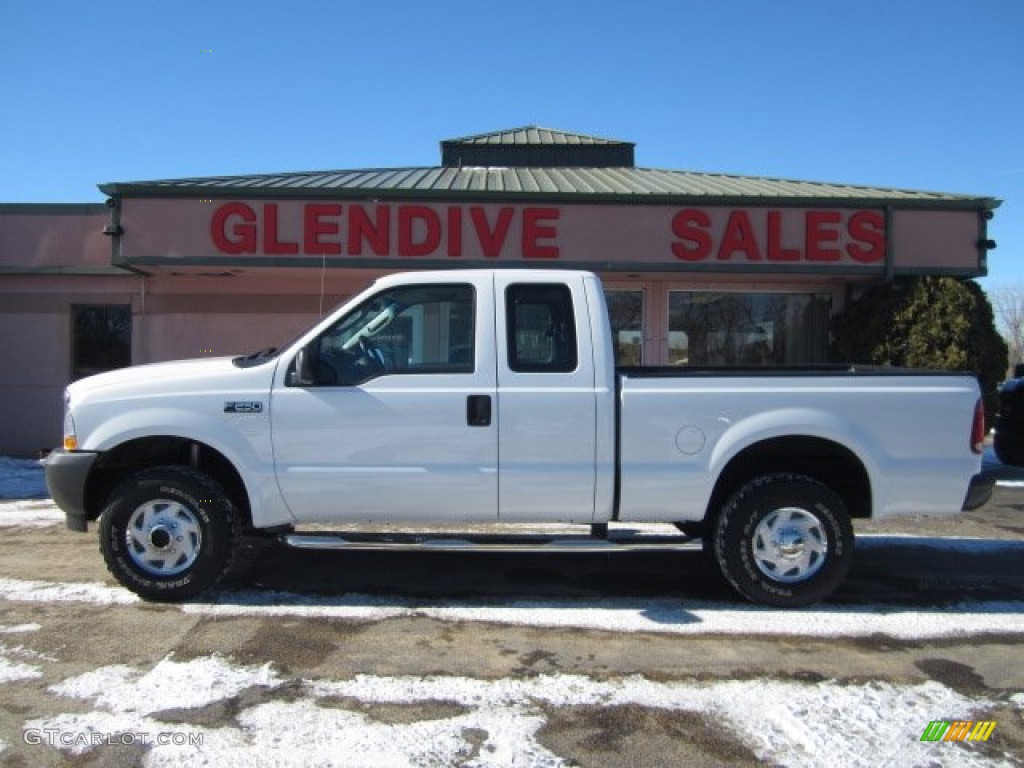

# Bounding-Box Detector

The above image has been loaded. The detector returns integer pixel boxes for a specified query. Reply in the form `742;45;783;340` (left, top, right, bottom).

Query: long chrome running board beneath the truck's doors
281;531;694;553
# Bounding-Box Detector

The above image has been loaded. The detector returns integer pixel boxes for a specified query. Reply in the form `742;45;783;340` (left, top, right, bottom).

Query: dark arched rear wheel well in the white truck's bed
705;436;871;522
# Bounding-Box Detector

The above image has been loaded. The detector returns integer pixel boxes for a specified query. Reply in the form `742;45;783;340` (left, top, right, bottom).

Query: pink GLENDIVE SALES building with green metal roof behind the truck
0;127;999;456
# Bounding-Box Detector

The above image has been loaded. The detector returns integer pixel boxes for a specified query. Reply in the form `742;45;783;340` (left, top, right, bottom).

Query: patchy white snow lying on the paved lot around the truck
0;459;1024;768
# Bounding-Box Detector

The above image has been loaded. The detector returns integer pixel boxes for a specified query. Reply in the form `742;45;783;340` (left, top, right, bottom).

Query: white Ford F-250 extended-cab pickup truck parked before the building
46;269;991;606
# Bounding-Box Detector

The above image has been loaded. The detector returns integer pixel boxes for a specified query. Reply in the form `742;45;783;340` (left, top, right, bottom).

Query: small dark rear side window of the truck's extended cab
505;284;578;373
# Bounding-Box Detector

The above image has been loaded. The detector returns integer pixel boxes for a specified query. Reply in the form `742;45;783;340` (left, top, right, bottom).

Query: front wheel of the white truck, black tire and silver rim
99;466;237;601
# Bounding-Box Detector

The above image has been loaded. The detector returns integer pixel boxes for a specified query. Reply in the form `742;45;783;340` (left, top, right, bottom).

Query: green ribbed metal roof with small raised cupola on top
99;126;999;210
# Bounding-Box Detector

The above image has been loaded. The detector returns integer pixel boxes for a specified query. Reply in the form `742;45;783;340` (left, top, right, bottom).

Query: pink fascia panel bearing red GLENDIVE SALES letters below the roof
121;199;979;271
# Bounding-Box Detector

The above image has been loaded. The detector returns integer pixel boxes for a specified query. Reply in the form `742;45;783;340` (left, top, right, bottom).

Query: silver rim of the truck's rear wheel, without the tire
753;507;828;584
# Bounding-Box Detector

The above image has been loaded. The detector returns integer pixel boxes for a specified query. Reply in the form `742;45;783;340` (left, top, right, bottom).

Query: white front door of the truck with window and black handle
271;276;498;521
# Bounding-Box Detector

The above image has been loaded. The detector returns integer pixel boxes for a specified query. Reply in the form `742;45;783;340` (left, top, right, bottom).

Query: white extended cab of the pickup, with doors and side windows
269;271;614;523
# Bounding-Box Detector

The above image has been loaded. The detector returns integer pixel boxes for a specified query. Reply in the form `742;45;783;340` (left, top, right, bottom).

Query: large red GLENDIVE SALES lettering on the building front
209;201;889;269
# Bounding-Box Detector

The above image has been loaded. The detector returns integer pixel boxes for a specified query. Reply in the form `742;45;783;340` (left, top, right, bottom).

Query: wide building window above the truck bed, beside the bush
669;291;831;367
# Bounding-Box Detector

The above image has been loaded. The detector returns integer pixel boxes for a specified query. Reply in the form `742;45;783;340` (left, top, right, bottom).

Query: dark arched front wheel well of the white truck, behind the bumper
85;436;252;525
